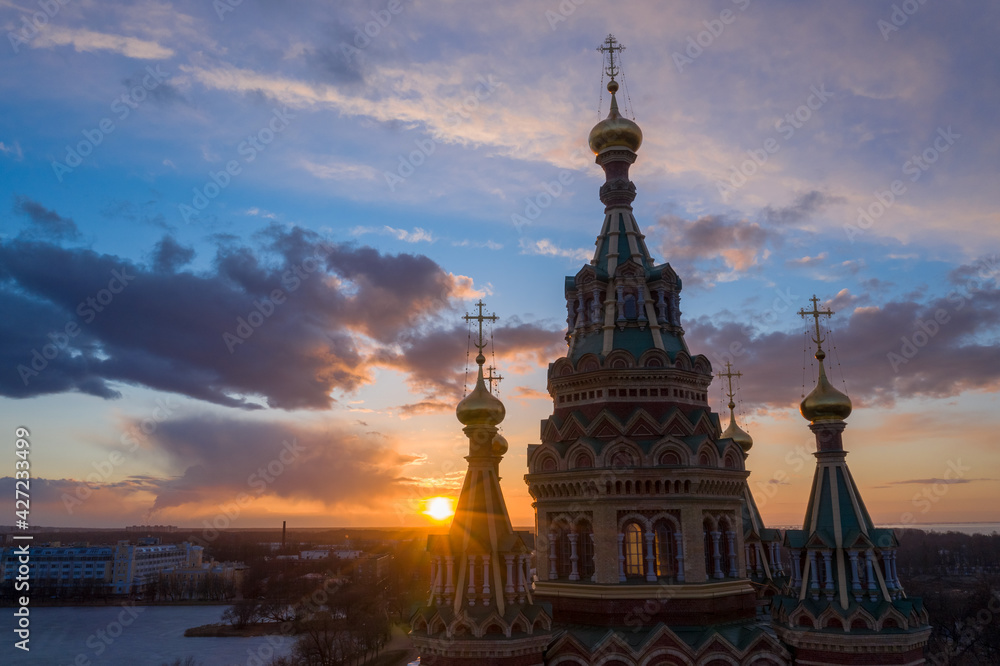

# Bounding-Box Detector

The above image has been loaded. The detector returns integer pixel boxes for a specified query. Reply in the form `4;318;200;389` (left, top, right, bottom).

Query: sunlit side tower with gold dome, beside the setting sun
410;301;552;666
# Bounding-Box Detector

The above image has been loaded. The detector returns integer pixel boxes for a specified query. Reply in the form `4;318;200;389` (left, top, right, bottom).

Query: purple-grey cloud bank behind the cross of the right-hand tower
685;288;1000;407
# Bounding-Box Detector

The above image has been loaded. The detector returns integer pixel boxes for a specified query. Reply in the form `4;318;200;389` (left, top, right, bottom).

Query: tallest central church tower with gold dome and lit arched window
525;35;787;666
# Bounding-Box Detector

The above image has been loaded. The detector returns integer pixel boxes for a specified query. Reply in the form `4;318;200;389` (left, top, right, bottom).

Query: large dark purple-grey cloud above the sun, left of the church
0;218;471;409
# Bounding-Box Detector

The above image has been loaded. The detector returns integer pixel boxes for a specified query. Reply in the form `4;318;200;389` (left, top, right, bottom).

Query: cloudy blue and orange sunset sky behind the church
0;0;1000;527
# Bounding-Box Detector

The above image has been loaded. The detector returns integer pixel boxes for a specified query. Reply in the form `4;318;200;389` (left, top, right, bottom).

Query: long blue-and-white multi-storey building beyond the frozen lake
0;541;203;594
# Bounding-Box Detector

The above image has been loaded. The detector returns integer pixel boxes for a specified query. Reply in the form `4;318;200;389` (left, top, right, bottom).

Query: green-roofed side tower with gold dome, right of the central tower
773;296;931;665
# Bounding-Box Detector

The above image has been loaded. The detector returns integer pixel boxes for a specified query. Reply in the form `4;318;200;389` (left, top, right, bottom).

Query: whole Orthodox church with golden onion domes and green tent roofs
410;35;930;666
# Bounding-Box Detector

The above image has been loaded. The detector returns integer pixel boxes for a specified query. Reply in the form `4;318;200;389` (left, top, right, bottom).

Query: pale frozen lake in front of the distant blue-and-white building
0;605;294;666
